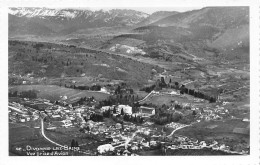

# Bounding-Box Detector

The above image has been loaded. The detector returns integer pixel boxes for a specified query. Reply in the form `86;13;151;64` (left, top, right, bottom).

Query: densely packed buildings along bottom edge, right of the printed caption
97;125;249;156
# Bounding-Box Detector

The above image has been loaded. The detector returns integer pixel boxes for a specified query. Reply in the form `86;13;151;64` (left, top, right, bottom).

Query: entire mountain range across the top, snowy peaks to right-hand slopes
9;7;249;61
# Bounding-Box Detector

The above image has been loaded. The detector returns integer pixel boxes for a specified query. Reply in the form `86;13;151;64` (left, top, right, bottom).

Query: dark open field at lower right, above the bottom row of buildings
175;119;249;151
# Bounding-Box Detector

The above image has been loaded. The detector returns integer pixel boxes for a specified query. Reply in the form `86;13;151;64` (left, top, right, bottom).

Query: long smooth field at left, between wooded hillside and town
9;85;109;101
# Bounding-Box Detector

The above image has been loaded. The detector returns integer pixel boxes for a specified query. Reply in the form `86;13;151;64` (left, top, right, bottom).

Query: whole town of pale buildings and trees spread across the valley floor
9;76;249;155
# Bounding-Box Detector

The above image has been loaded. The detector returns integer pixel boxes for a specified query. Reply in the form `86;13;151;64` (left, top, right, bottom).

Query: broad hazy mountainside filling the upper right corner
133;7;249;48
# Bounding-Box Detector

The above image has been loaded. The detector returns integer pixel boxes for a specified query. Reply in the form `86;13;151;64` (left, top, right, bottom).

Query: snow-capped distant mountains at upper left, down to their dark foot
9;8;149;35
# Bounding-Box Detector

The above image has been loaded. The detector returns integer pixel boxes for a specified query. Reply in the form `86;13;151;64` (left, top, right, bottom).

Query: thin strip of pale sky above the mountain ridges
63;7;202;14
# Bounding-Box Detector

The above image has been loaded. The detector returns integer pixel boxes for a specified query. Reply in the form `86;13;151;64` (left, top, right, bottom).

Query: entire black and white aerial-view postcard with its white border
1;1;259;164
